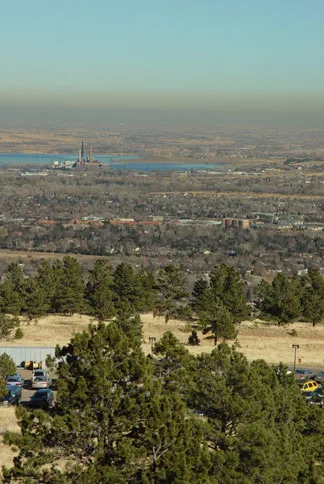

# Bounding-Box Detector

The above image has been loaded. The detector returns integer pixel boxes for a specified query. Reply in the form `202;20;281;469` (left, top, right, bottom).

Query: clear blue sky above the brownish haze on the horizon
0;0;324;105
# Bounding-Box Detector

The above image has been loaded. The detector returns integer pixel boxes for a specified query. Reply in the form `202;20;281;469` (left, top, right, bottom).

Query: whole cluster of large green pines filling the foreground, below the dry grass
3;317;324;484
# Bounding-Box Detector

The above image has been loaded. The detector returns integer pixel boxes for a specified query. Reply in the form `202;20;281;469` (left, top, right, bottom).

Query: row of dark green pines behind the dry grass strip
0;257;324;344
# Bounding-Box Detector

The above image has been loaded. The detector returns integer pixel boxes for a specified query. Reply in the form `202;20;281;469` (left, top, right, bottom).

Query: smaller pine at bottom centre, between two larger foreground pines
135;382;215;484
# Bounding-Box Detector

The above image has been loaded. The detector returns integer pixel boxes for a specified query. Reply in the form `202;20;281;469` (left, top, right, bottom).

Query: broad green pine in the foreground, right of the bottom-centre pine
191;345;316;484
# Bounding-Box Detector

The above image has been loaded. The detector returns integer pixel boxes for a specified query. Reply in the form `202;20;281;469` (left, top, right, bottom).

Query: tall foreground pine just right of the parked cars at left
2;323;151;484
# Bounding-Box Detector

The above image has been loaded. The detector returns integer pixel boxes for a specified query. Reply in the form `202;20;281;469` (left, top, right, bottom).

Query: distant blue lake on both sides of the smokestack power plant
0;153;222;172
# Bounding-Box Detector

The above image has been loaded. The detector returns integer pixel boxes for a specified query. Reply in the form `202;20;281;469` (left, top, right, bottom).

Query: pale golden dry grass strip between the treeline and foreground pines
0;314;324;368
